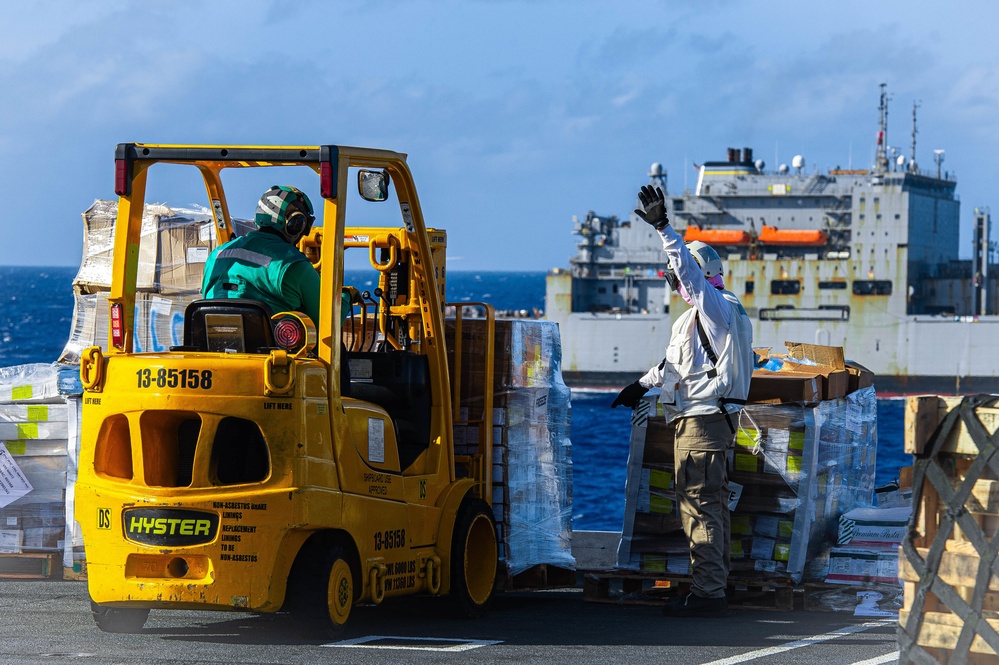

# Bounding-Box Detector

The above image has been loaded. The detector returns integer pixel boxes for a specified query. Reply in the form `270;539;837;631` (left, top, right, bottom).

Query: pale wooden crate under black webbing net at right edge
898;395;999;665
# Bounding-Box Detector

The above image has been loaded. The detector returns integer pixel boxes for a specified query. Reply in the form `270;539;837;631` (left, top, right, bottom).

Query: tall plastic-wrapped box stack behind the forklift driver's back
59;200;252;363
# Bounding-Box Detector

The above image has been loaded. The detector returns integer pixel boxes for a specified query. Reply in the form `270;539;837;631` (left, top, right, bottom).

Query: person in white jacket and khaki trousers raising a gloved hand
612;186;753;616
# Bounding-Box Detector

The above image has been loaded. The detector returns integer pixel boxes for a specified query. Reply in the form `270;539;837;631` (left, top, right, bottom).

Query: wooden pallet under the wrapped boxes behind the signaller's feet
583;571;806;612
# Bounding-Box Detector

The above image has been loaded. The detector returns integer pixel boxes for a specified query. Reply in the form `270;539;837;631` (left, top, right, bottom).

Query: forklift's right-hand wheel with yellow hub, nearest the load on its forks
449;497;499;619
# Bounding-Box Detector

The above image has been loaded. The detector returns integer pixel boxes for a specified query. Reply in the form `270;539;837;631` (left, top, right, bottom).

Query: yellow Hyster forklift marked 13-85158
76;143;498;632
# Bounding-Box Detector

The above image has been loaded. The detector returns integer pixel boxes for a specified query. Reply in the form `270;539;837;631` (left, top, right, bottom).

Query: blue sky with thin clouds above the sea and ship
0;0;999;270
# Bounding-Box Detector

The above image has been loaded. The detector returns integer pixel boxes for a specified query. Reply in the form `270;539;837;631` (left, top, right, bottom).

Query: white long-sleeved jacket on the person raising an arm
639;226;753;422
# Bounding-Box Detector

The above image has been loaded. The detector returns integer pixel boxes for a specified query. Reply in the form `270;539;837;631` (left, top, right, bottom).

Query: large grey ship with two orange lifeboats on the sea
545;84;999;394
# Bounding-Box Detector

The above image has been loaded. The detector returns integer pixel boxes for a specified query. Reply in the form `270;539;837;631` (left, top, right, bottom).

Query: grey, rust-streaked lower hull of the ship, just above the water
559;314;999;395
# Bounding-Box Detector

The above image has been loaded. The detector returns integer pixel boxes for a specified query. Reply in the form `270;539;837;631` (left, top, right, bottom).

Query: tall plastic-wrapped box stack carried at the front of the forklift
446;319;575;576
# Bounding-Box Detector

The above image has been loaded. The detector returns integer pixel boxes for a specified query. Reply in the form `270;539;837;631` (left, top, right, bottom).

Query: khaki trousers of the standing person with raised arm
673;413;737;598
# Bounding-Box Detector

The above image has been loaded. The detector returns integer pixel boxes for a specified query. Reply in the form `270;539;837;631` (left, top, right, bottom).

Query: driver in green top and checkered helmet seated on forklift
201;185;320;324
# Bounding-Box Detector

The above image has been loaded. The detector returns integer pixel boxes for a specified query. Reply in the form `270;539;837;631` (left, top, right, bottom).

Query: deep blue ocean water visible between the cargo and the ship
0;267;911;530
